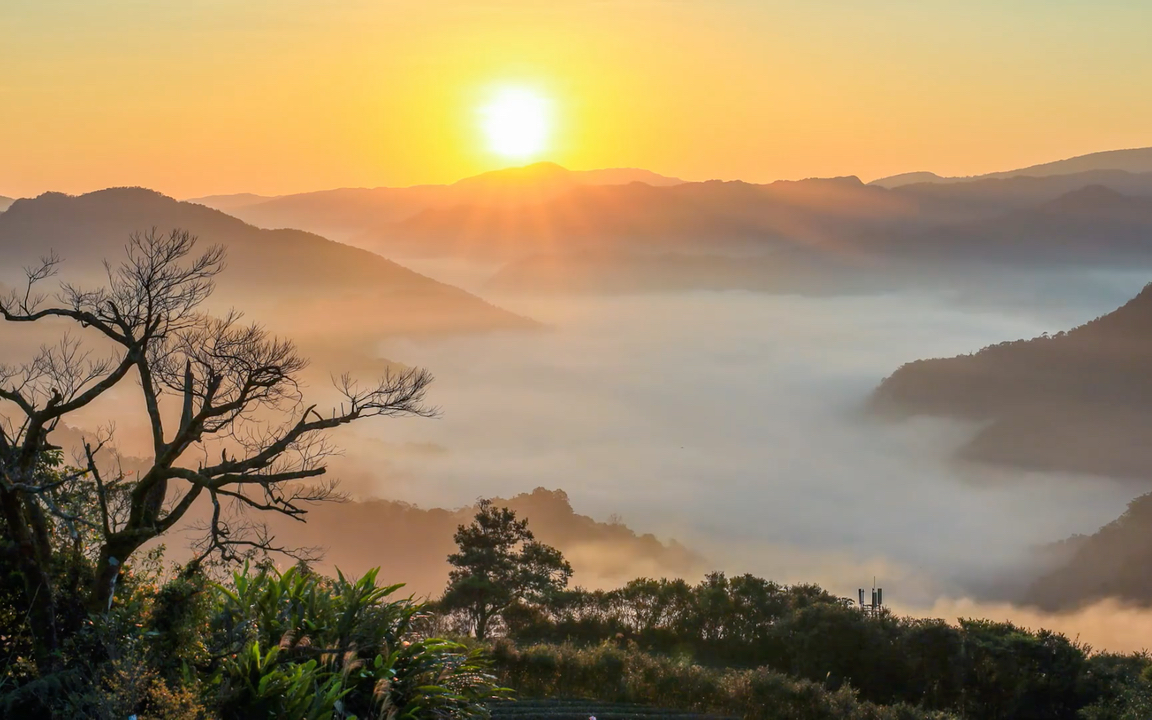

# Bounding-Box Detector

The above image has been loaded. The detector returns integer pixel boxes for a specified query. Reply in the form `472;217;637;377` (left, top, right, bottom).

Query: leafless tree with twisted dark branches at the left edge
0;229;433;669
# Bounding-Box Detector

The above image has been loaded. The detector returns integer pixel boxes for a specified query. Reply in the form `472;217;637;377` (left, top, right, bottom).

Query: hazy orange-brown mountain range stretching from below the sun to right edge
380;170;1152;265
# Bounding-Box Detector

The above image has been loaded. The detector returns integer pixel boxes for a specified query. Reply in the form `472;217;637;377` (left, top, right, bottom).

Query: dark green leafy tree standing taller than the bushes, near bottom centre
440;500;573;639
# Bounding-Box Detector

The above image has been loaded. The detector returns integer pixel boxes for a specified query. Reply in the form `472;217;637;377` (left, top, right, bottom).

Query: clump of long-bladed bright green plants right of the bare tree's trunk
211;566;506;720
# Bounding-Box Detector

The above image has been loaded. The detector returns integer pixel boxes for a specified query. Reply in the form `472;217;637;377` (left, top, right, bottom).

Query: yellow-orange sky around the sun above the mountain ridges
0;0;1152;197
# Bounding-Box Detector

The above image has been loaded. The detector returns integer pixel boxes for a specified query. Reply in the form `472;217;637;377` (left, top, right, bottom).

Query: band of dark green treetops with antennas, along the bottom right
505;573;1152;720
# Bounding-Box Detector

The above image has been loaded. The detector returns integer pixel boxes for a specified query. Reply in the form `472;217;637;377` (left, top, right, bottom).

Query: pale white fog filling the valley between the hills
344;265;1145;608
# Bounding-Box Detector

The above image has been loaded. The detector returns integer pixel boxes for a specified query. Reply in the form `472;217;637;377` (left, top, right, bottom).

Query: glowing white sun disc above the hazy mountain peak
480;88;552;160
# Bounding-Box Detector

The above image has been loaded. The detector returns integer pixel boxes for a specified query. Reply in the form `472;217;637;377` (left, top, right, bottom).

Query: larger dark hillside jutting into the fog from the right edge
870;286;1152;483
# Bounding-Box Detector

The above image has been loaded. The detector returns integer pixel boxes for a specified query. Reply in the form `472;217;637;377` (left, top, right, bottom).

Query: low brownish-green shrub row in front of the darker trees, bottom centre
492;641;953;720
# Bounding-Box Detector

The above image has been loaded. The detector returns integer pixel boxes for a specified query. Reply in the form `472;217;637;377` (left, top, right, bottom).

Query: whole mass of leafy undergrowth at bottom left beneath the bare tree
0;566;506;720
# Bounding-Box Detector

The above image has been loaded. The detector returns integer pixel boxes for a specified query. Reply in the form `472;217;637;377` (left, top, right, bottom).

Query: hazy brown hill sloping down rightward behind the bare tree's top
0;188;532;334
